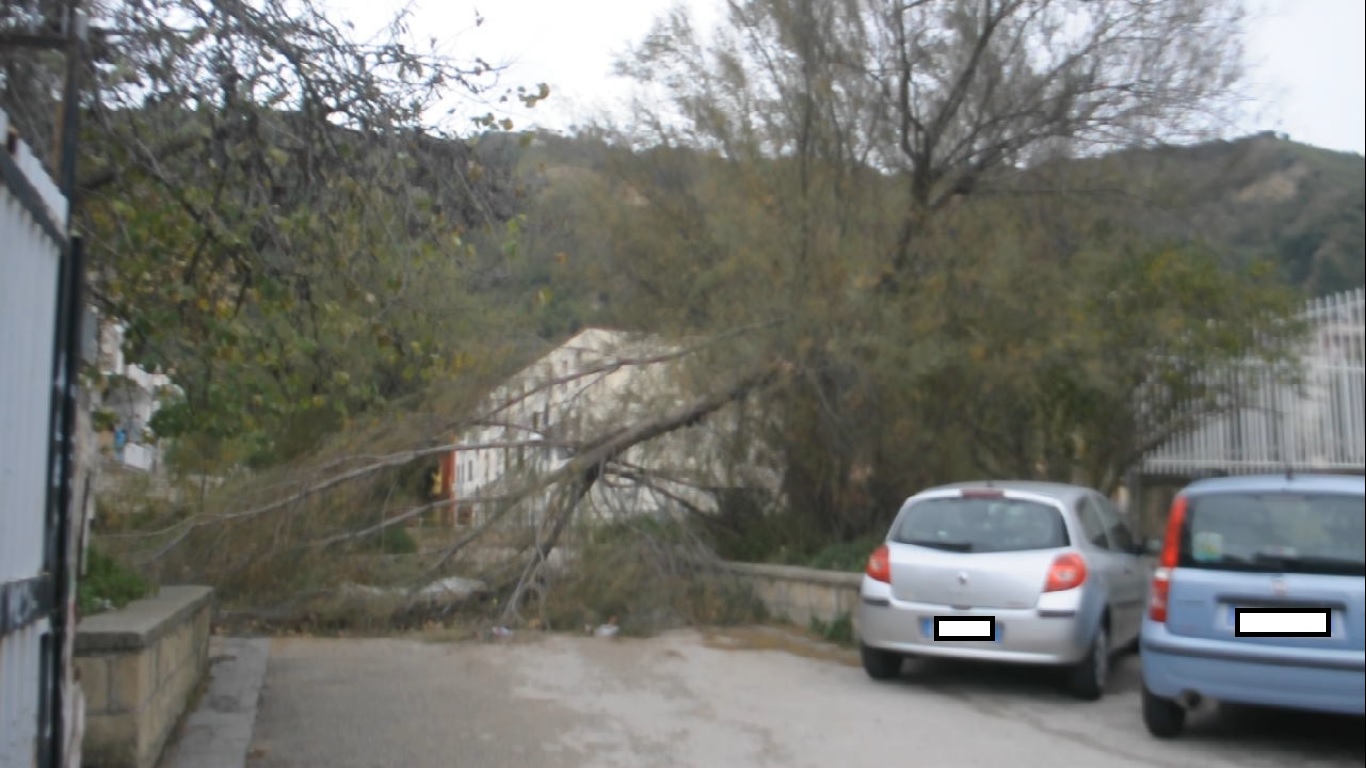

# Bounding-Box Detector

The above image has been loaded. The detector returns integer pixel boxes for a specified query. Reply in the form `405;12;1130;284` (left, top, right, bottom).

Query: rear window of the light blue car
1179;493;1366;575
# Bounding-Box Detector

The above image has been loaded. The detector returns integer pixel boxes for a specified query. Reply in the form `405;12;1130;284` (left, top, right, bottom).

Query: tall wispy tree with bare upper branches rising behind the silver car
584;0;1294;538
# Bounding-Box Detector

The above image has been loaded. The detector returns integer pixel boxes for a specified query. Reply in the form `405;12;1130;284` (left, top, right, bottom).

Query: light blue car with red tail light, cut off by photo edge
1139;474;1366;738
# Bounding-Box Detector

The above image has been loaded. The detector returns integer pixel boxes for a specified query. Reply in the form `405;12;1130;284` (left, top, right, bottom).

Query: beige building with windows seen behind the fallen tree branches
444;328;780;525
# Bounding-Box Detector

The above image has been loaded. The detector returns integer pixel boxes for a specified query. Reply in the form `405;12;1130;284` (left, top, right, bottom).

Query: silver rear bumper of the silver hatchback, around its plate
858;585;1094;666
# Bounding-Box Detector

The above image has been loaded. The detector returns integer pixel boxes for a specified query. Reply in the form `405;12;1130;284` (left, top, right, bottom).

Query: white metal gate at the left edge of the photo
0;112;67;767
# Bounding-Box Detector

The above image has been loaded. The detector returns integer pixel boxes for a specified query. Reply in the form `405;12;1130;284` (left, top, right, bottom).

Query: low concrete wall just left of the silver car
727;563;863;634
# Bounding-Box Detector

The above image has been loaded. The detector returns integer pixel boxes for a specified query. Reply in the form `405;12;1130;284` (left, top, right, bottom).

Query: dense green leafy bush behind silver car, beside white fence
932;192;1300;491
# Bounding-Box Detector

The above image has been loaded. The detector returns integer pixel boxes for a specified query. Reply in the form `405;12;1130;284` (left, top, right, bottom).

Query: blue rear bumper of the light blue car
1141;622;1366;715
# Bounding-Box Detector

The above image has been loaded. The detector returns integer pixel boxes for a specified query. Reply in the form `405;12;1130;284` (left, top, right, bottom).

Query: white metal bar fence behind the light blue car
1143;288;1366;476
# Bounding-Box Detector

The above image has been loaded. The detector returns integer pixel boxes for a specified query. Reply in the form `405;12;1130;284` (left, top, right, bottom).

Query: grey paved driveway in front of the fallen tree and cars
250;630;1366;768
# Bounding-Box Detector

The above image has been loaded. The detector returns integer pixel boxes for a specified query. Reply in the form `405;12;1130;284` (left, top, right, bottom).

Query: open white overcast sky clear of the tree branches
324;0;1366;153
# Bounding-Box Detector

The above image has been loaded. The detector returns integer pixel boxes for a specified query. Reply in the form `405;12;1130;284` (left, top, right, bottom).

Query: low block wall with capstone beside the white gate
75;586;213;768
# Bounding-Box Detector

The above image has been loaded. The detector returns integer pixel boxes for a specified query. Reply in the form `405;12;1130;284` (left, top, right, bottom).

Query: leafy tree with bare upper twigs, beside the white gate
3;0;546;461
